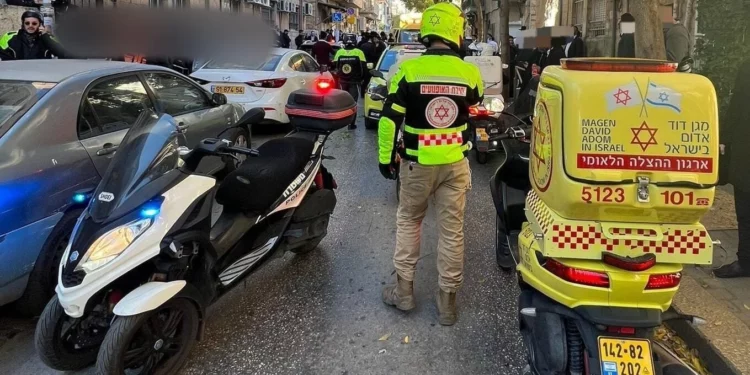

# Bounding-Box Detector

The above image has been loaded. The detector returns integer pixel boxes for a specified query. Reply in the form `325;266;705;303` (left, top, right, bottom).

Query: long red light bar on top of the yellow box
561;59;677;73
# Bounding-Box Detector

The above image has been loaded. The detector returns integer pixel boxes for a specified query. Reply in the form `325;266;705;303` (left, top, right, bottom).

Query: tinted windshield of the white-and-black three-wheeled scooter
89;111;180;222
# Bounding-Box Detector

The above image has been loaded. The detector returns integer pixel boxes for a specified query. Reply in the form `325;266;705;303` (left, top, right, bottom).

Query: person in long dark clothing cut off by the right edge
714;59;750;278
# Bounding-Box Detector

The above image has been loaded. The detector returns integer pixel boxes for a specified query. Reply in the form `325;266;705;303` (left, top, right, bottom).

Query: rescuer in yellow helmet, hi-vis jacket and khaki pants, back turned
378;2;484;325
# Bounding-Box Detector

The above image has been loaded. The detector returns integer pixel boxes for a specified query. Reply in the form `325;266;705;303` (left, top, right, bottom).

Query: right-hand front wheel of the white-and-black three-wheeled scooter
96;298;200;375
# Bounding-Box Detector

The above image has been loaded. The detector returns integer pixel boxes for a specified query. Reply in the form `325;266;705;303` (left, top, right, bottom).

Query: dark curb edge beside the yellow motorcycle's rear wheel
666;307;742;375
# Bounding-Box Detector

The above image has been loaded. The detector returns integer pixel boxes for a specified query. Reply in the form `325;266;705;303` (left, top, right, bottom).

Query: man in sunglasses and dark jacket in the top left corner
0;10;65;60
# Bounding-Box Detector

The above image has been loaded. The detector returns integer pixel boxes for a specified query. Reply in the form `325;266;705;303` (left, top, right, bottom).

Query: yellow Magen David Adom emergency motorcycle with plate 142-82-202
491;59;719;375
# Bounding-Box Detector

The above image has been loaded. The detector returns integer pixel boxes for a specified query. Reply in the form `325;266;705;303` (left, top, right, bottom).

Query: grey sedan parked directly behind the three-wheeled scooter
0;60;250;314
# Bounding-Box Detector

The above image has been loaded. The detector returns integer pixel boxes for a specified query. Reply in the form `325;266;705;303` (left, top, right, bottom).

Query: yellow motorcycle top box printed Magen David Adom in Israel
526;58;719;264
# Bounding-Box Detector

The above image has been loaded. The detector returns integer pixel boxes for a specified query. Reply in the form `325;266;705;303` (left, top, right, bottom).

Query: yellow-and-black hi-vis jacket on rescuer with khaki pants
378;49;484;165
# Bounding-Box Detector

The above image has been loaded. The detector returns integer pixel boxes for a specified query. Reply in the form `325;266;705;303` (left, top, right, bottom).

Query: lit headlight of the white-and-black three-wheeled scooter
76;218;151;273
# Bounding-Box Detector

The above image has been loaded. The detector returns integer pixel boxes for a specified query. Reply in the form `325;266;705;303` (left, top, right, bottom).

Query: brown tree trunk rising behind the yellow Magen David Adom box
630;0;667;60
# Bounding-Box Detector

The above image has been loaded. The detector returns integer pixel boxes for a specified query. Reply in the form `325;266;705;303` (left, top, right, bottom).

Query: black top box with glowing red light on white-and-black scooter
285;80;357;134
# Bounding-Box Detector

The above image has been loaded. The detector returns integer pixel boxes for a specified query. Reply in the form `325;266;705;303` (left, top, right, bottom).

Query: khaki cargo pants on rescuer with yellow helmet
393;158;471;293
